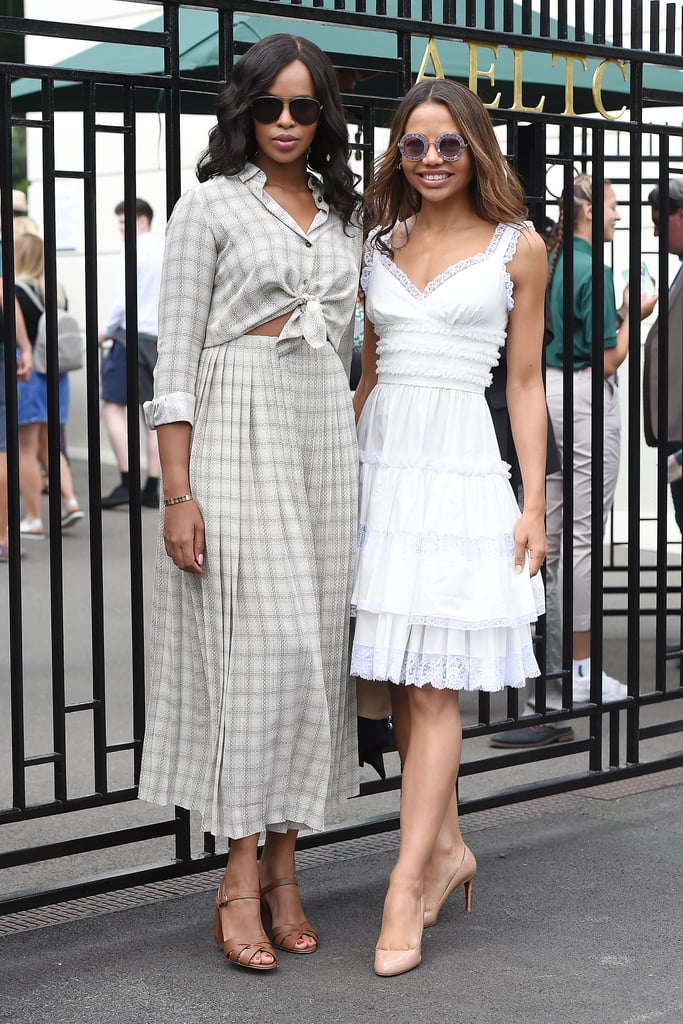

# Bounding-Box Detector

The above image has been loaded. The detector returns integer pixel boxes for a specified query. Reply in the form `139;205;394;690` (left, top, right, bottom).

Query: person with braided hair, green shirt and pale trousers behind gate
546;174;656;702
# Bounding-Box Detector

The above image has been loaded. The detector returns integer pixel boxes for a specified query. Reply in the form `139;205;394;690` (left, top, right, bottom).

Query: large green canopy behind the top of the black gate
12;0;683;114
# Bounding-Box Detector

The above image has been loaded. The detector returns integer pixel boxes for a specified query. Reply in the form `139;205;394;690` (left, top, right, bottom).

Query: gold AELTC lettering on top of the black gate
417;38;628;121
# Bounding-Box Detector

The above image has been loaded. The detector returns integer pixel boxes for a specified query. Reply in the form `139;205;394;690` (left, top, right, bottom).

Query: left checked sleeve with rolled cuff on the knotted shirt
144;189;217;429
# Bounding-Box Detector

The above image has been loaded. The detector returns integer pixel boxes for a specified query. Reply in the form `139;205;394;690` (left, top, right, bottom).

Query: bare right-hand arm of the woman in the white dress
506;231;548;575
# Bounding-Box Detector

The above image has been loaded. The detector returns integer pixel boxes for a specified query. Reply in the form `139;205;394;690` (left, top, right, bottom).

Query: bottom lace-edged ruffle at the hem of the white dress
351;642;541;692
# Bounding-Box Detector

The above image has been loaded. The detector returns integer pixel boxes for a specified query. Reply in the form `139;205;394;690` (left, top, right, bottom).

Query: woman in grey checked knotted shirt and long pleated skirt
139;35;361;970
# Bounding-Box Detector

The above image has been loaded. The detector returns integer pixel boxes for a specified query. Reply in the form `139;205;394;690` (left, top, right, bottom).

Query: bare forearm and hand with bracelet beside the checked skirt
157;422;204;575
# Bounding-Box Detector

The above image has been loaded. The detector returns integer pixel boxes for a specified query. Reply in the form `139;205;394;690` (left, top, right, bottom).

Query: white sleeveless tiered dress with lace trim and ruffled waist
351;224;544;691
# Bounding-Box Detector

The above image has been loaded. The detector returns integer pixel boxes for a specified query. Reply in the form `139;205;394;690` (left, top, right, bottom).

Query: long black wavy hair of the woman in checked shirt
197;33;361;227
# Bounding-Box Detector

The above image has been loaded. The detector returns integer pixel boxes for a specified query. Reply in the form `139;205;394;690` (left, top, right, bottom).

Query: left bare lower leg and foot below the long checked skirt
220;834;274;965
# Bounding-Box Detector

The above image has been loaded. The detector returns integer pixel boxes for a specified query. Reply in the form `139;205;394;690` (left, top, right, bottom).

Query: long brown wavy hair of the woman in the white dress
366;79;526;252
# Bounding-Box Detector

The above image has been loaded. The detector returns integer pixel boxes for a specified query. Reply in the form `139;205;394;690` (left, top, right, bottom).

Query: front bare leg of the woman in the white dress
378;686;462;949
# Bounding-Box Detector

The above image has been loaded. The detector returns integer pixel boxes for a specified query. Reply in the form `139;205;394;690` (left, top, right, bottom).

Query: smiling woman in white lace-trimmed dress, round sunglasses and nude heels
351;81;546;975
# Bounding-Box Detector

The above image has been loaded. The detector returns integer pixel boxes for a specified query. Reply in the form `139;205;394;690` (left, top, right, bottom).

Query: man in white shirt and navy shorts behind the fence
99;199;164;509
